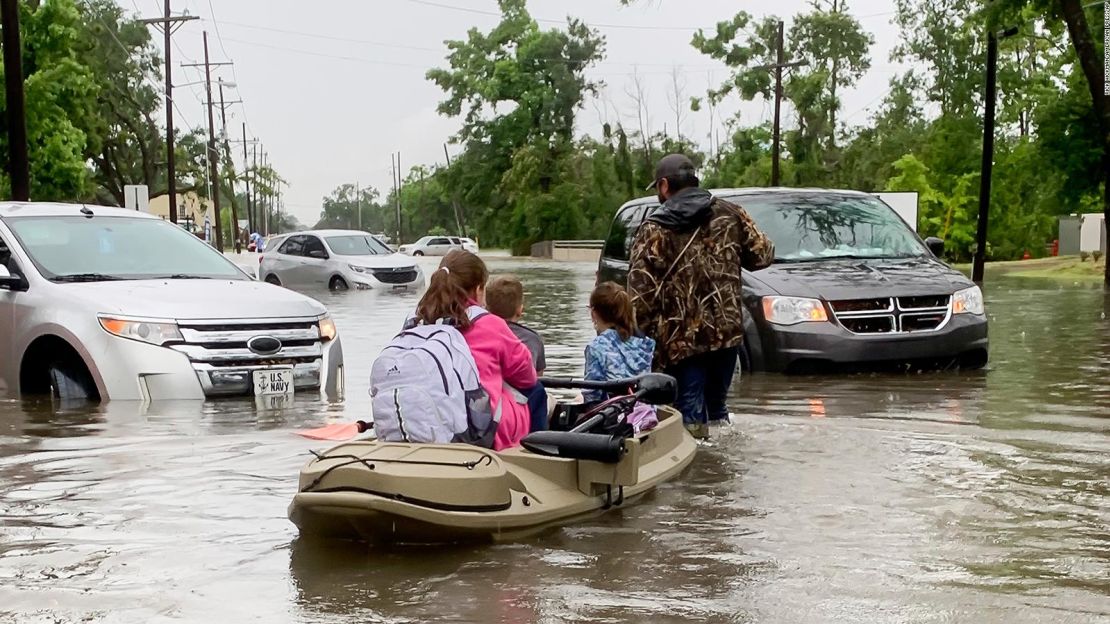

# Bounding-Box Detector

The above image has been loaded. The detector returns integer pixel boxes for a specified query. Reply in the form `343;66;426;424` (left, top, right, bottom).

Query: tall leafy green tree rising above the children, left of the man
427;0;604;245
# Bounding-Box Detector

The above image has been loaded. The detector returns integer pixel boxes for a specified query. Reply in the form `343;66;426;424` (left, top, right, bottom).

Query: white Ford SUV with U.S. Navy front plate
0;203;343;401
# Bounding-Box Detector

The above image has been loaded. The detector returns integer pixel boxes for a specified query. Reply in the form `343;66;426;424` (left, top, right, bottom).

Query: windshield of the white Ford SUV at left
7;217;249;281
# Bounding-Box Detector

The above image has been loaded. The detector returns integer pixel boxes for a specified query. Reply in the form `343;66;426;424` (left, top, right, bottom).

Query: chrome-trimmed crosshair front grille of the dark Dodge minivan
829;294;951;335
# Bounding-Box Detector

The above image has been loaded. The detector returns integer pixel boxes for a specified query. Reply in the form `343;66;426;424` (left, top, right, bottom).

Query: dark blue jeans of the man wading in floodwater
665;346;740;424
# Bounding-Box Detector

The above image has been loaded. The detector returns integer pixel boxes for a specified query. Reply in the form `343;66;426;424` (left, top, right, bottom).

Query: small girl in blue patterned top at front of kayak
583;282;655;424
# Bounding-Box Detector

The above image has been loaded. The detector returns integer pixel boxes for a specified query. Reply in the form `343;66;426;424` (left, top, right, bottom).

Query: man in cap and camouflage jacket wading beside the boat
628;154;775;439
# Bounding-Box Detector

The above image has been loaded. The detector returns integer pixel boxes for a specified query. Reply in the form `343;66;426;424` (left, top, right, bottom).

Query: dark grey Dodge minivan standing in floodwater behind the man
597;189;988;373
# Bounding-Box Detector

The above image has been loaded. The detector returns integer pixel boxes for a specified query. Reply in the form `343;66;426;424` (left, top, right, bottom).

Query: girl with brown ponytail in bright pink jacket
415;250;547;451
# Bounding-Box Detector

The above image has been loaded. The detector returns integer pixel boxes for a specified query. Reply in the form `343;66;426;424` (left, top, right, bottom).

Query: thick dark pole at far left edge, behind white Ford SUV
0;0;31;201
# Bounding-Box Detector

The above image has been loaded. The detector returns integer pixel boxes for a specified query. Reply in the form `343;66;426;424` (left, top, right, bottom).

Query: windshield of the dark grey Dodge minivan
729;192;928;262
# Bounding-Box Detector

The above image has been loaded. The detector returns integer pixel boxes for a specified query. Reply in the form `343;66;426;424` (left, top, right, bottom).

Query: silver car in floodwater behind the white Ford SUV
259;230;424;290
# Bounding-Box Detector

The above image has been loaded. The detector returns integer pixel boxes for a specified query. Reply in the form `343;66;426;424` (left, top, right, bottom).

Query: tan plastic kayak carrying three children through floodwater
289;395;697;544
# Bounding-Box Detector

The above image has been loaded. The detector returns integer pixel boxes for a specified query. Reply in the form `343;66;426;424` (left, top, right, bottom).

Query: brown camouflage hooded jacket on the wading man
628;189;775;370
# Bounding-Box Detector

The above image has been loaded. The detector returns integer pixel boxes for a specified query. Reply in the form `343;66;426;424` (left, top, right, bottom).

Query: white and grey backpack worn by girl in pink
370;305;501;449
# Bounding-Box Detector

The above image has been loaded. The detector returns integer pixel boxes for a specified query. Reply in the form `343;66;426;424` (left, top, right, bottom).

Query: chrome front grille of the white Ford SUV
170;319;324;395
